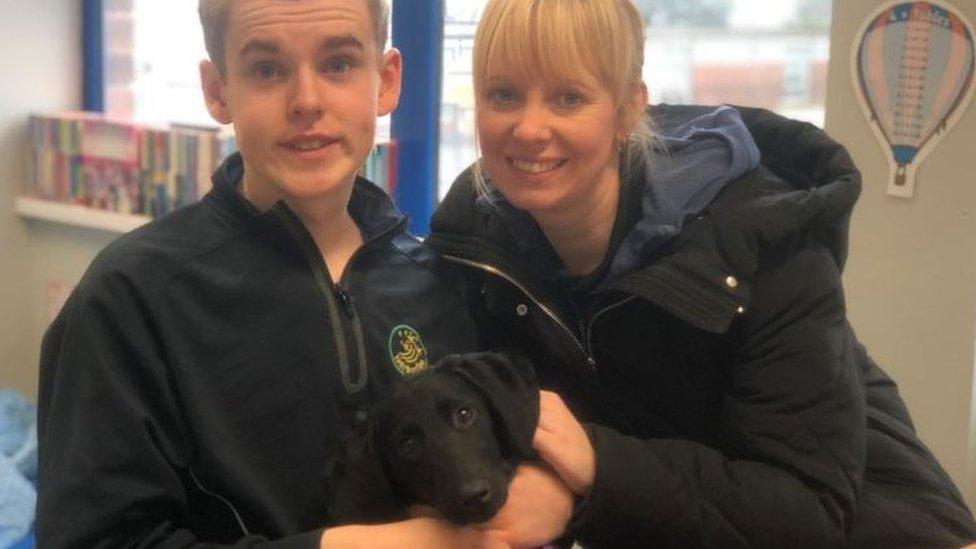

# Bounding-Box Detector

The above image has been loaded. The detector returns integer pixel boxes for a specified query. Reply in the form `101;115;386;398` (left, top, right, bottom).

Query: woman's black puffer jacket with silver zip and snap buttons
429;107;976;548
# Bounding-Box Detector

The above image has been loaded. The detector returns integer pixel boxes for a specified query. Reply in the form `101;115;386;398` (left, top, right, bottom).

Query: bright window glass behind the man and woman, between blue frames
93;0;831;222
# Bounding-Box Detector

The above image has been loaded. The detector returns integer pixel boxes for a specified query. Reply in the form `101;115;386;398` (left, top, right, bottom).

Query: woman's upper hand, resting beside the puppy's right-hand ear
532;391;596;496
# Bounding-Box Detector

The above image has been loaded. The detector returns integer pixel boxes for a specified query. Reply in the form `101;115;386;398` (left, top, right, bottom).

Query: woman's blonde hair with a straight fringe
473;0;654;194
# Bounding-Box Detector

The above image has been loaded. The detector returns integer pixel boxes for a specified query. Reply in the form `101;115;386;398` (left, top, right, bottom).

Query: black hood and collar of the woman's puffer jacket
429;106;861;333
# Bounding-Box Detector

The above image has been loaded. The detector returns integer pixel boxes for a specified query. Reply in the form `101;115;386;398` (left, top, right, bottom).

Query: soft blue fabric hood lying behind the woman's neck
607;106;760;279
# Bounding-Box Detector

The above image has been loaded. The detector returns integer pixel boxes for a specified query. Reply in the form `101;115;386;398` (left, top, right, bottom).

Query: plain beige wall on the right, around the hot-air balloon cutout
826;0;976;507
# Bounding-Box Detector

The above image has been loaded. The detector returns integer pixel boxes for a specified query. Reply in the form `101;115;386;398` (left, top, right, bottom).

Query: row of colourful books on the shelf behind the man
28;112;396;217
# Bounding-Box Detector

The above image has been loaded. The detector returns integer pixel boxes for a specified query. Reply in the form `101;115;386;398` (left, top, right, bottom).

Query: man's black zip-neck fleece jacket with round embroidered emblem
37;156;477;549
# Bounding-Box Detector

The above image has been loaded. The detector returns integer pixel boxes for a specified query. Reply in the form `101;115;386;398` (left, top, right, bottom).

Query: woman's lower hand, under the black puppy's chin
478;464;574;549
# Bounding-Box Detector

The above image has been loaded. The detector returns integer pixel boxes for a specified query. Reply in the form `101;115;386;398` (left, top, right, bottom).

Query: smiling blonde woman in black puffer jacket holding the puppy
430;0;976;548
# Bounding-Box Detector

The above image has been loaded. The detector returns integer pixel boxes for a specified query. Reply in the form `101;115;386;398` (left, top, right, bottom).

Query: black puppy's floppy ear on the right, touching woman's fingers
438;353;539;459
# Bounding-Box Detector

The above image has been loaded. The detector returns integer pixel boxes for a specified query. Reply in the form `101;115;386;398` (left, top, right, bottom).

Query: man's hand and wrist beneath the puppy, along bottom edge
319;517;510;549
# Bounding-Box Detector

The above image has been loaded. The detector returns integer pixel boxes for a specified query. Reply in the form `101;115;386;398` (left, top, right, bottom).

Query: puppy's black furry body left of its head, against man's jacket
326;420;403;525
